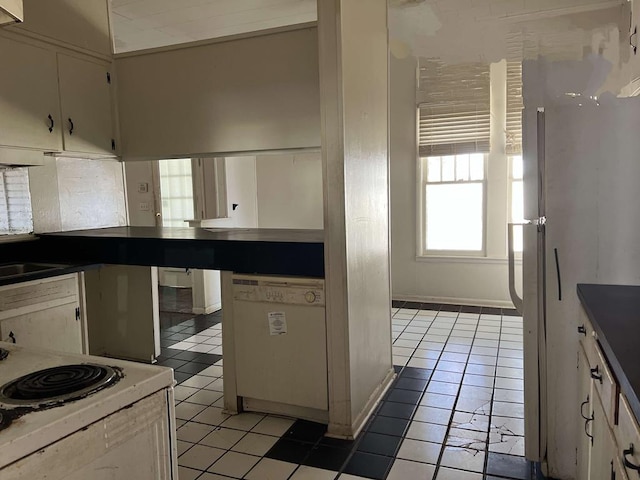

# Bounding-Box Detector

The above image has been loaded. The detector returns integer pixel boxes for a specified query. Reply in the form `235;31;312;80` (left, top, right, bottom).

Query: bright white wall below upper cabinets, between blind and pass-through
29;157;127;233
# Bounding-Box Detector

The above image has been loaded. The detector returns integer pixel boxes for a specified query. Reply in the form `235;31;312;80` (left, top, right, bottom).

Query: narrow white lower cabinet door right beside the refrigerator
577;344;592;479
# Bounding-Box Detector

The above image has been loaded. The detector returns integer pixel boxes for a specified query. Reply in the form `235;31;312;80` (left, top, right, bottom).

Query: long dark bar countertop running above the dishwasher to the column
28;227;324;278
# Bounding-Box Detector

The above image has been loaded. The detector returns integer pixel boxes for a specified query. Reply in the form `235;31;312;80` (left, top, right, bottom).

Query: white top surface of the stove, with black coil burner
0;342;174;468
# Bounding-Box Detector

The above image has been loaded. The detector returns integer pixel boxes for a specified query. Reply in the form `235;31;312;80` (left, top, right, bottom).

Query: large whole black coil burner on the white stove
0;363;121;407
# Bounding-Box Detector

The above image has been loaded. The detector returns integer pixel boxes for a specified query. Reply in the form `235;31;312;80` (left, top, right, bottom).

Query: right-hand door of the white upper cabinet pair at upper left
58;53;114;156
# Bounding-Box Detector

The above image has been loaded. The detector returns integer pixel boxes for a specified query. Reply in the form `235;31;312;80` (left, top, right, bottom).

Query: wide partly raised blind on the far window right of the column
418;60;491;157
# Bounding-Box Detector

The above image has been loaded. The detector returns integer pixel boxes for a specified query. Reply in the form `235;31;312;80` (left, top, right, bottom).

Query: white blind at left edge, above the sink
0;167;33;235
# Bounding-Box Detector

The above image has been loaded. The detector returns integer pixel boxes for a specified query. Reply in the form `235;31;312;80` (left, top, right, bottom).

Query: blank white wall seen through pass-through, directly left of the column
256;153;324;229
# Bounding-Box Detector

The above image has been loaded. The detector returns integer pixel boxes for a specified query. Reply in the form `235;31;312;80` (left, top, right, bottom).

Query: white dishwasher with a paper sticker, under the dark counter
232;274;328;420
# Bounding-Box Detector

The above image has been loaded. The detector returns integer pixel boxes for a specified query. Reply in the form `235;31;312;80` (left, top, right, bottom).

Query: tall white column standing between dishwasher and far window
318;0;394;437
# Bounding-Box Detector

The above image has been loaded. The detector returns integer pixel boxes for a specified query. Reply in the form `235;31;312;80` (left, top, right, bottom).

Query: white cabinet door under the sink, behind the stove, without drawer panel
0;302;83;353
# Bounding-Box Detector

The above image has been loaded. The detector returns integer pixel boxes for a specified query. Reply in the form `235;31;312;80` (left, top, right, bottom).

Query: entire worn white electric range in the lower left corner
0;342;178;480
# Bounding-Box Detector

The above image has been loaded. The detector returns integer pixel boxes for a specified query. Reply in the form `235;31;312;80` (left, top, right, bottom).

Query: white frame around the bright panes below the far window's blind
416;153;489;258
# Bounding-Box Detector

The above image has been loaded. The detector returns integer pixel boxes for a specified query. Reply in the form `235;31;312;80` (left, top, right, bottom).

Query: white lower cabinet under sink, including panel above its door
0;273;86;353
